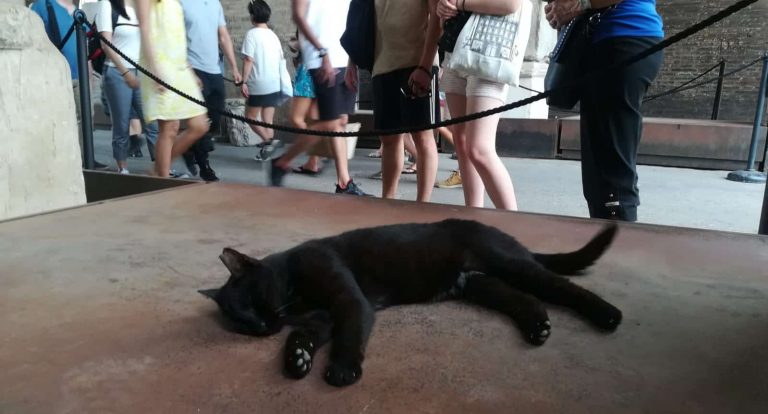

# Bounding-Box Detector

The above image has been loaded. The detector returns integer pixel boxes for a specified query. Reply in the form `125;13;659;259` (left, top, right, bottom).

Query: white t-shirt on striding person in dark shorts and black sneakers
299;0;350;69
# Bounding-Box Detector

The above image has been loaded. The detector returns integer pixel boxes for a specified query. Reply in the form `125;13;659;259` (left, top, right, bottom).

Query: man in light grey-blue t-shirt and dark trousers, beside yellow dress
180;0;242;181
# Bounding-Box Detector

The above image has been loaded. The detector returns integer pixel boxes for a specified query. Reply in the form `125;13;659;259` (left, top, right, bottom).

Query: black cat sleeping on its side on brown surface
200;219;621;386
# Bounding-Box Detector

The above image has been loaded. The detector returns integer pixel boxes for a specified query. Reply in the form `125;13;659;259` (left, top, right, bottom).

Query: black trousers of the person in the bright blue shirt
581;37;664;221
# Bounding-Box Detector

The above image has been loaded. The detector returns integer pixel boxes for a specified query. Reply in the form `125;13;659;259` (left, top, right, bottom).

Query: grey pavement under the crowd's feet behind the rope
94;130;765;233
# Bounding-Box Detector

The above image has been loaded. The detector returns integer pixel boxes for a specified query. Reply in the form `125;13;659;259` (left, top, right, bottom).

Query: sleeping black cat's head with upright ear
199;248;285;336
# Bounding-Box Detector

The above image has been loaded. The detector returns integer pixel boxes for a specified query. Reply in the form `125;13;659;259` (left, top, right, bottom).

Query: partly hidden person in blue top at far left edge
30;0;107;170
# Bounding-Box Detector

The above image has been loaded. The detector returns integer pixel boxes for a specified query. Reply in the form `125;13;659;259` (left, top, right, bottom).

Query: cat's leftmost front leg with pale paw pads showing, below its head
283;311;332;379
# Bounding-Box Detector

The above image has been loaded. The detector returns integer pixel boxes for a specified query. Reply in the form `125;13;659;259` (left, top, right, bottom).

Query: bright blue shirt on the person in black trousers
593;0;664;42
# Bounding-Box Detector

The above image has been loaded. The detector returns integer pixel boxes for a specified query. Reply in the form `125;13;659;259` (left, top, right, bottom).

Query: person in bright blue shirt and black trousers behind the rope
544;0;664;221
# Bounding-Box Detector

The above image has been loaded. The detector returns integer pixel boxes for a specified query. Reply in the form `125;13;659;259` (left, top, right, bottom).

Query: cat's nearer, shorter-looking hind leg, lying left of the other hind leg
463;274;551;346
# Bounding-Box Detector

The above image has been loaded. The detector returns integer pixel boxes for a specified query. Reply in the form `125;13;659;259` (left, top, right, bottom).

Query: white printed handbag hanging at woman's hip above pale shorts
446;0;533;86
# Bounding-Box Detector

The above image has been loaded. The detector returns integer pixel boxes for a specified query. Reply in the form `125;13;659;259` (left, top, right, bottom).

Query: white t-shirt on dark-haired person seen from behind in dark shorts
240;27;283;95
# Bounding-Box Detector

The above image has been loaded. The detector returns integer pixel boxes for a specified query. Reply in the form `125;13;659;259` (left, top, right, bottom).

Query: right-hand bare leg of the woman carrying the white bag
459;96;517;210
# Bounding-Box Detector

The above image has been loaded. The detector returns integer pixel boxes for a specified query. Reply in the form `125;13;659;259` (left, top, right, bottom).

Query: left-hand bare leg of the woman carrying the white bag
446;93;485;207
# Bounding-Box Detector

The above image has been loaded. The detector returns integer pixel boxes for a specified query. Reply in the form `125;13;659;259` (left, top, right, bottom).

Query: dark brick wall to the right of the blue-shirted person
643;0;768;121
